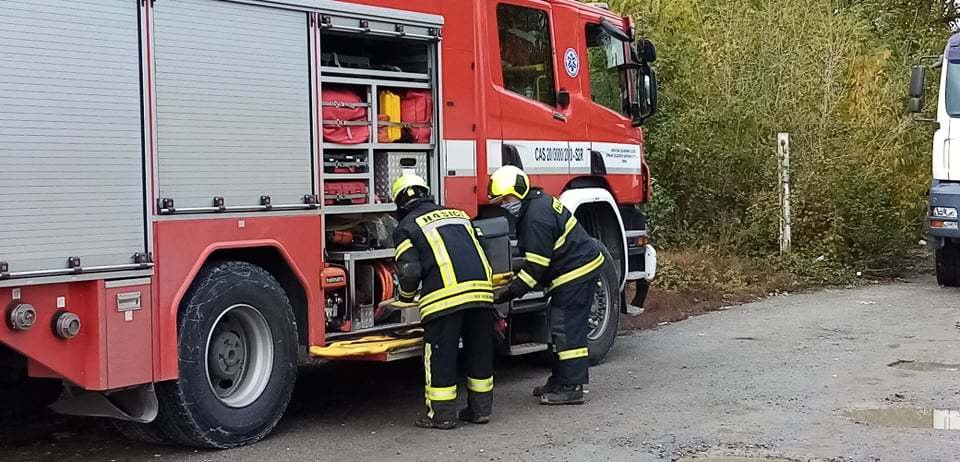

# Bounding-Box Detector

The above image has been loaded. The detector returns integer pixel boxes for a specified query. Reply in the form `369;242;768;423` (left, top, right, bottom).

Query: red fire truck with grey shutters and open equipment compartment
0;0;656;448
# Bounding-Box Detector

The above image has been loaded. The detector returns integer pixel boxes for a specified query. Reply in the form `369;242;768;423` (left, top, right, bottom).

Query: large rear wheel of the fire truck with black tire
155;262;298;449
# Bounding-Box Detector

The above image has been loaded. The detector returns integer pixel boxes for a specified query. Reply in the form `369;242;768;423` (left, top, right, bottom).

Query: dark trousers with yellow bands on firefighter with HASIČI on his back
423;306;496;420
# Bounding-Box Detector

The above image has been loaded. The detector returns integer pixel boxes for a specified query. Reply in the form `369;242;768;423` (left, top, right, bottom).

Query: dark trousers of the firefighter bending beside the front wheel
549;274;599;385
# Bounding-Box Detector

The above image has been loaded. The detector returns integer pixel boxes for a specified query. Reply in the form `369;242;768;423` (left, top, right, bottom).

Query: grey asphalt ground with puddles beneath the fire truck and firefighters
0;277;960;462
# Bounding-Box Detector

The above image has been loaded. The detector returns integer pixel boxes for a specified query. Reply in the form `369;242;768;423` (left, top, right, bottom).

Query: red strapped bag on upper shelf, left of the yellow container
320;87;370;144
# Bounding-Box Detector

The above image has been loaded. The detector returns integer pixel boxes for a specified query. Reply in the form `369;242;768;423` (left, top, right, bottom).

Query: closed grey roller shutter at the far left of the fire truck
0;0;146;273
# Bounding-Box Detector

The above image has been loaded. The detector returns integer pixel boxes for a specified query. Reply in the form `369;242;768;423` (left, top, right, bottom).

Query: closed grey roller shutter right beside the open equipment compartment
154;0;313;208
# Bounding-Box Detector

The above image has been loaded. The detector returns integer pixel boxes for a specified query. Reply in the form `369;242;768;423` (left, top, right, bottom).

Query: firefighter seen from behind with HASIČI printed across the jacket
391;173;496;429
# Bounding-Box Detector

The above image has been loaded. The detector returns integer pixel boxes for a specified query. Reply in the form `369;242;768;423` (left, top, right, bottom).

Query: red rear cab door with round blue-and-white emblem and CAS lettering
487;0;587;188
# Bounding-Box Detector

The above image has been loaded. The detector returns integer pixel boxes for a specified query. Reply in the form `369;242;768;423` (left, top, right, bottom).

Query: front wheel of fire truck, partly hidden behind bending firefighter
587;244;623;366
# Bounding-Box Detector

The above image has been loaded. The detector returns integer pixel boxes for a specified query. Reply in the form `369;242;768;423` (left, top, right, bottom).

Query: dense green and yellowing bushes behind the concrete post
609;0;957;272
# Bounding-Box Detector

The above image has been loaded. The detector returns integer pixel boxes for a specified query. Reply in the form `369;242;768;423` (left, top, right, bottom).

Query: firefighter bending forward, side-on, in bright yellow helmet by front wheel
488;166;604;404
